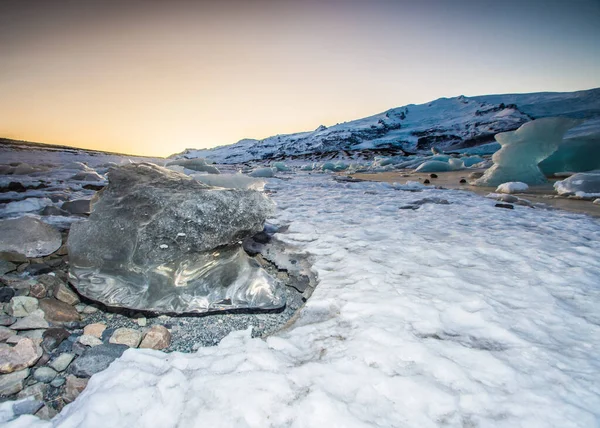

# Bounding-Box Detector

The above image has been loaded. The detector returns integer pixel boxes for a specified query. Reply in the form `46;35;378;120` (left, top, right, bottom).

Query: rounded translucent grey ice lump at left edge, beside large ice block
0;217;62;257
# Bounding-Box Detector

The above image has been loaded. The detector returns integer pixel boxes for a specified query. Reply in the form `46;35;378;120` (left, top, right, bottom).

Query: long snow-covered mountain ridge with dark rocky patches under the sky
177;88;600;164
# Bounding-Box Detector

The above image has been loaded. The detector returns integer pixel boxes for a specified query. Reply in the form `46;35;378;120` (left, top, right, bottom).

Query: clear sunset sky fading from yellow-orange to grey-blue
0;0;600;156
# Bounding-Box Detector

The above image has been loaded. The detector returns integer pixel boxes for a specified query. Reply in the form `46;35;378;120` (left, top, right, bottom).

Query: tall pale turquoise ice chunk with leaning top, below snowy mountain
473;117;581;186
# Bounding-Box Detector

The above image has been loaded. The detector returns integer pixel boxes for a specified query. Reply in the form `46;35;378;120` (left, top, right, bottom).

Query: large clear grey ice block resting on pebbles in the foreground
68;164;284;313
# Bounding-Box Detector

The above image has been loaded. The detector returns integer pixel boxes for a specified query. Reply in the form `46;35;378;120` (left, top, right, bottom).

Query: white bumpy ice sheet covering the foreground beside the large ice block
14;175;600;427
